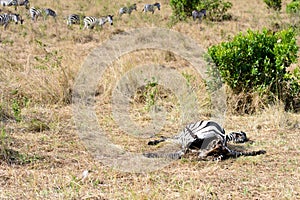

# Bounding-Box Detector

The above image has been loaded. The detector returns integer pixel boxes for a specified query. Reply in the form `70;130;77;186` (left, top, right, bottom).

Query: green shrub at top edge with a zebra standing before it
170;0;232;21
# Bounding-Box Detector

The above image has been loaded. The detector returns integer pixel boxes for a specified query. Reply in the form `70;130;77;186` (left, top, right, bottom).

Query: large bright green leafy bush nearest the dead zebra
208;29;300;111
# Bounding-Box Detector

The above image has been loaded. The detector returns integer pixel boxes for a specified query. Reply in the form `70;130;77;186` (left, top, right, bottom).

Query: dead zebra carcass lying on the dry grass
144;120;266;160
